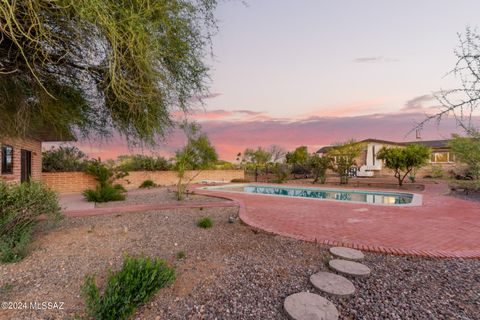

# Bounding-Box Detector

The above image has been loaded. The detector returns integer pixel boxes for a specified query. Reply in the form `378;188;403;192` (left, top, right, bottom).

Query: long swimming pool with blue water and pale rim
204;184;421;205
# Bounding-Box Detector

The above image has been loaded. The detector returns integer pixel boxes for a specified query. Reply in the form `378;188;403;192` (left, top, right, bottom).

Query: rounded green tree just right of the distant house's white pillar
377;144;430;186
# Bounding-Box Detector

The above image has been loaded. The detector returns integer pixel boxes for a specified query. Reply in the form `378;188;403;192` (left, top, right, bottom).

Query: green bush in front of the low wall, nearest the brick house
83;160;128;202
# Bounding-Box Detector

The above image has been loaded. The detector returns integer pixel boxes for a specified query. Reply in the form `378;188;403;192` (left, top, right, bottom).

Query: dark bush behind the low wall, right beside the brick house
42;146;87;172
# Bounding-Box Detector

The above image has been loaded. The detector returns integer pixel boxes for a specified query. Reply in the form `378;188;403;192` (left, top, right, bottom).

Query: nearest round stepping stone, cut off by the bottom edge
283;292;338;320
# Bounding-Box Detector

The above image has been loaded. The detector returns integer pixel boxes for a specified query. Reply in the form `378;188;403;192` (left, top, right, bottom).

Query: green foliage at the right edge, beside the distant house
448;131;480;179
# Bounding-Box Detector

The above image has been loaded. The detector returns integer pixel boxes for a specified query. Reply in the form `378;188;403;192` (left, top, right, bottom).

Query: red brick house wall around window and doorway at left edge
0;138;42;182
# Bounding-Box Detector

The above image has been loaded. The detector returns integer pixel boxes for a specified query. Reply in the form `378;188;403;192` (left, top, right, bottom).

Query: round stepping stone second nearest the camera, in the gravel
310;272;355;297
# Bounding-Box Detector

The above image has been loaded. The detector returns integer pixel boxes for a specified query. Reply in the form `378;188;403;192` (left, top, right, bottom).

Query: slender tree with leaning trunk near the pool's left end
174;121;218;201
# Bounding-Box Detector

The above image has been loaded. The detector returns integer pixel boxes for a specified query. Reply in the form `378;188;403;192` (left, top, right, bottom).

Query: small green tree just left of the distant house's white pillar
327;140;364;184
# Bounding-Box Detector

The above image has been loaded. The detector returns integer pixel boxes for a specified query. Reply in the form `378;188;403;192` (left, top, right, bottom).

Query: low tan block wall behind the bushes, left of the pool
42;170;245;193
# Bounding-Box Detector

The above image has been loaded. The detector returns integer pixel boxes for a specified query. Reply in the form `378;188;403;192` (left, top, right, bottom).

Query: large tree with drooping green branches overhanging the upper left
0;0;216;144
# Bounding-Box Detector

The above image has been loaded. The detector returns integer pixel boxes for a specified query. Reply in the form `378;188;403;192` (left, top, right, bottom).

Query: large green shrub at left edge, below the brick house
0;181;61;263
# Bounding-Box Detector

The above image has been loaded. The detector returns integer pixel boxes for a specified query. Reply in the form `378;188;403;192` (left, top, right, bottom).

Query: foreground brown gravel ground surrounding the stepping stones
0;204;480;320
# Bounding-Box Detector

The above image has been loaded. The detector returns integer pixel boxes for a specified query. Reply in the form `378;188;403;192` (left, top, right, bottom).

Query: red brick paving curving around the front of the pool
196;184;480;258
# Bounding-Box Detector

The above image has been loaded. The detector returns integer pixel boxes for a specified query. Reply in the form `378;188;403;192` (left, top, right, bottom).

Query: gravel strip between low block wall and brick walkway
95;187;226;208
